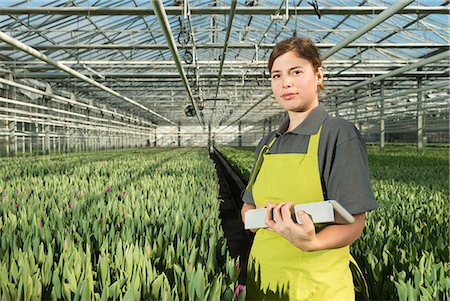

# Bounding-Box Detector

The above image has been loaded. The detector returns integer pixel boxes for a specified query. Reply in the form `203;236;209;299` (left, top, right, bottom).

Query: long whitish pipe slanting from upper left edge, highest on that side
0;31;176;125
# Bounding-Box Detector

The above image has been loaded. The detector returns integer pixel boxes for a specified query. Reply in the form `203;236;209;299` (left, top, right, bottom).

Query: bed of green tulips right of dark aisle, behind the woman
216;147;450;300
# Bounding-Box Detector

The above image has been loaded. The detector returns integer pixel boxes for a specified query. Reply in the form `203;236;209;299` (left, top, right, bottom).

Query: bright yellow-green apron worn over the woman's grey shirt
246;129;364;301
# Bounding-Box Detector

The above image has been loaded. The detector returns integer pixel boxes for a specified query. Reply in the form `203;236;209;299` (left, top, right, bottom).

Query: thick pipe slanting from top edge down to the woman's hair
322;0;414;60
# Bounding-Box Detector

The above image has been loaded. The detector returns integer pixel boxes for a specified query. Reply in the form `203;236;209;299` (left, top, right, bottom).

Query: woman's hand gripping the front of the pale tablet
266;202;318;251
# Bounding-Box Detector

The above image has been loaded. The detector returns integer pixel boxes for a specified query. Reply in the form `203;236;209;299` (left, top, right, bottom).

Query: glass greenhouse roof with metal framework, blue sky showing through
0;0;450;127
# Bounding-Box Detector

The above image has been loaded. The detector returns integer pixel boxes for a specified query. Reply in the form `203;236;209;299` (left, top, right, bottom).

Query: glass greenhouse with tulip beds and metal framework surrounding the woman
0;0;450;300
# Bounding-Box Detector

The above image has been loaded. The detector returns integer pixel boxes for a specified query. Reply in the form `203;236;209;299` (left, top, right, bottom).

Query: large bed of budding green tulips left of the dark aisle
0;149;243;300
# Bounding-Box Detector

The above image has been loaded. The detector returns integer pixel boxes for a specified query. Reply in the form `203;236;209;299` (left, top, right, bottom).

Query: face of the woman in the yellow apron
271;51;323;112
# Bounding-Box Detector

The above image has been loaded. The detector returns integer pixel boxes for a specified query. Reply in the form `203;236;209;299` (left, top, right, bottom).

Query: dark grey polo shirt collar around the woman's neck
277;104;329;135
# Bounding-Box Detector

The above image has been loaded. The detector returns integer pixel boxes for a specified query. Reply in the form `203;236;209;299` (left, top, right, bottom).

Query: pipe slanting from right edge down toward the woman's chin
322;51;450;100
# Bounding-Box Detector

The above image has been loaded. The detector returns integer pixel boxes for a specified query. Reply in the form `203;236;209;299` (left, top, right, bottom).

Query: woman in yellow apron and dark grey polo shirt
242;37;377;300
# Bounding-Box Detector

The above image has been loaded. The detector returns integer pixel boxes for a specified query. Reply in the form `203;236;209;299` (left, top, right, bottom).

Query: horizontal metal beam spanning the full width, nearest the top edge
0;6;450;16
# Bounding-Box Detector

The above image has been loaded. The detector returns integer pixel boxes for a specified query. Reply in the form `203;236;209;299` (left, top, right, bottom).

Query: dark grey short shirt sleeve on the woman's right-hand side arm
323;122;378;214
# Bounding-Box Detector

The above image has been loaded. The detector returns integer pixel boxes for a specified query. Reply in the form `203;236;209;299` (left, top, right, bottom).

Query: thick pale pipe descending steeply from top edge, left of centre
150;0;205;128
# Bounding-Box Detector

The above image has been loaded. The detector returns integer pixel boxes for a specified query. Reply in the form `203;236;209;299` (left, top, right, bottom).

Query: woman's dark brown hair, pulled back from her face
268;37;324;91
